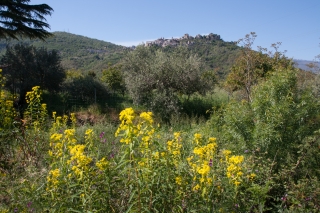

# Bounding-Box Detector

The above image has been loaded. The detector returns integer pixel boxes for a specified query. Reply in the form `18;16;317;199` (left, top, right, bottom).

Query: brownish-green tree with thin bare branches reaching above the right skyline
226;32;294;101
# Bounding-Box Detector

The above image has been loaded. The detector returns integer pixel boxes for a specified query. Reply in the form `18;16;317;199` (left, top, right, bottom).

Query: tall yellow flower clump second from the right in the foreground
187;133;217;191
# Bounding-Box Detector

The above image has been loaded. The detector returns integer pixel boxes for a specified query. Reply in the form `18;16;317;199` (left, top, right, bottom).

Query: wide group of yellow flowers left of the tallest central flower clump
47;116;110;205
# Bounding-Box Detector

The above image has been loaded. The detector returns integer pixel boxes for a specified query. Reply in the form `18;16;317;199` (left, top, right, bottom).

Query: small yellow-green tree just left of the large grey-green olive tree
101;63;126;95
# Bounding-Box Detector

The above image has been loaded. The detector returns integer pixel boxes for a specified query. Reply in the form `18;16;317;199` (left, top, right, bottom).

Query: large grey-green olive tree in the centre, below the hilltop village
123;46;212;121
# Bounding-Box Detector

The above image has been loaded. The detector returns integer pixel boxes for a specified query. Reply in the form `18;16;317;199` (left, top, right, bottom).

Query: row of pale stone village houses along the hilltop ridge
145;33;221;47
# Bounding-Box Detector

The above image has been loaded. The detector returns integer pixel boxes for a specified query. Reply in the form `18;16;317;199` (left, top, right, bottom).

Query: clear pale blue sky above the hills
29;0;320;60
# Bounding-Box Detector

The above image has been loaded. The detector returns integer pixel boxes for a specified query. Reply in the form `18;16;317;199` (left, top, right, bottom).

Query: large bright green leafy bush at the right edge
215;70;320;158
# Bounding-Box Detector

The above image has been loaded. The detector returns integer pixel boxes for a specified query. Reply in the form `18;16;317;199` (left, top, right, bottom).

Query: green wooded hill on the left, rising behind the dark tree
0;32;130;71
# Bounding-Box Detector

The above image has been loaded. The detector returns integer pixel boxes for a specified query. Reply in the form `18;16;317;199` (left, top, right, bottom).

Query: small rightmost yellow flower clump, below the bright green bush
223;150;244;187
